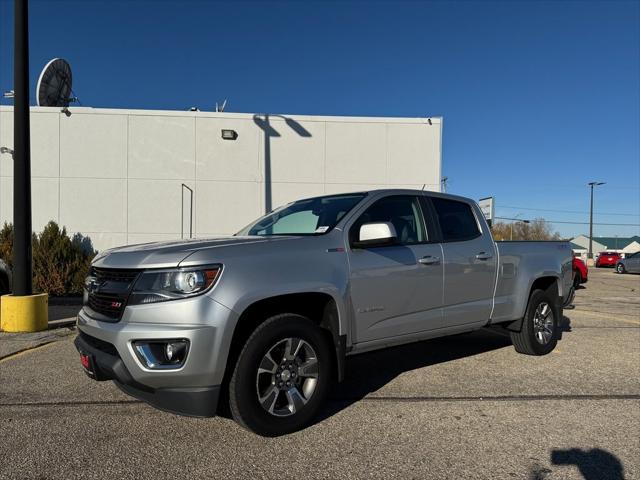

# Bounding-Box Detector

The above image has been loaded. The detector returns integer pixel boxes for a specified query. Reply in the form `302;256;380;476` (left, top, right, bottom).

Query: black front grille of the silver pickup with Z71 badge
85;267;140;321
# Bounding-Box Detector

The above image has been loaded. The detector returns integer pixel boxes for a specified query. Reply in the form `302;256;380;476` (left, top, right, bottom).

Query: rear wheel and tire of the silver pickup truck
511;290;559;355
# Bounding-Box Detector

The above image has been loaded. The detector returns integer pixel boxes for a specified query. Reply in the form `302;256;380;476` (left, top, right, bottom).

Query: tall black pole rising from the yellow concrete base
13;0;33;297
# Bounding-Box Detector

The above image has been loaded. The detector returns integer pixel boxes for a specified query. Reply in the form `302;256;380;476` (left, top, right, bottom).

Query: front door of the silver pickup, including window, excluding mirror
349;195;443;343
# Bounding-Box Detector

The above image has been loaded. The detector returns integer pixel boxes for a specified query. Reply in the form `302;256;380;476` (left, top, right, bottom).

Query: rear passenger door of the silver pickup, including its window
427;196;497;326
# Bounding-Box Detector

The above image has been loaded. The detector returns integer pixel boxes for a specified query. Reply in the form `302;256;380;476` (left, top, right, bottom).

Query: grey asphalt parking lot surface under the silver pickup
0;268;640;479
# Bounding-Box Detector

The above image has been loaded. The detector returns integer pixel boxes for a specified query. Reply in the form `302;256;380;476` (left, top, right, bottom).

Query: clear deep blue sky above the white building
0;0;640;240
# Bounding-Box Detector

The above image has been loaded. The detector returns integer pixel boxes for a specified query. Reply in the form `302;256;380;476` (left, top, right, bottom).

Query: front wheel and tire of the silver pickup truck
229;314;335;437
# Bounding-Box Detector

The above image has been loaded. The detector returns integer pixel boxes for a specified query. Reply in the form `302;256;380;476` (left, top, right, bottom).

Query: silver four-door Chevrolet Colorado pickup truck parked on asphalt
75;190;572;436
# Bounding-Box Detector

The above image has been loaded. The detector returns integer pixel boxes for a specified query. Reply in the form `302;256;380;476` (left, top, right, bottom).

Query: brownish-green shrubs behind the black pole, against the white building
0;221;96;295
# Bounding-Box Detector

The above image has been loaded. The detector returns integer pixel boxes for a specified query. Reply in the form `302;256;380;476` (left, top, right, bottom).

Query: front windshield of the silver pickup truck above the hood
236;193;366;236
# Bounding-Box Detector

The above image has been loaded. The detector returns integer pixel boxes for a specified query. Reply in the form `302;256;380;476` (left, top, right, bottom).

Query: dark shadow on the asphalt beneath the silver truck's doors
316;330;512;422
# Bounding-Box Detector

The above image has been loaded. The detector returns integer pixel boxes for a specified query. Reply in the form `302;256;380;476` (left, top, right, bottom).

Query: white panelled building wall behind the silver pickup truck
0;107;442;250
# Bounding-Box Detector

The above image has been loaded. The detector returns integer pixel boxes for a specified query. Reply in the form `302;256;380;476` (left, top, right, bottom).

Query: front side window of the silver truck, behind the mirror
349;195;427;245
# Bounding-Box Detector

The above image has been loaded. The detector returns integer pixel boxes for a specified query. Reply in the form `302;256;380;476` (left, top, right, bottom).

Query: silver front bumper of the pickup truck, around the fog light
75;296;237;417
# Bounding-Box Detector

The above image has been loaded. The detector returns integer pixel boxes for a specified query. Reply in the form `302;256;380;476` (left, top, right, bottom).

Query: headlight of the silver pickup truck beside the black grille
128;265;222;305
